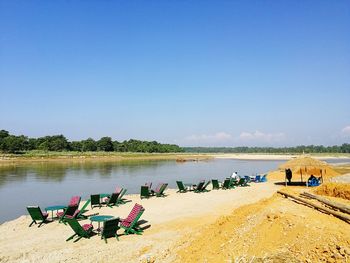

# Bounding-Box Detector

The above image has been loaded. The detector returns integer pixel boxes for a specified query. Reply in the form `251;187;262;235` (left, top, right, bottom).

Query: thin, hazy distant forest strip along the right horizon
183;143;350;154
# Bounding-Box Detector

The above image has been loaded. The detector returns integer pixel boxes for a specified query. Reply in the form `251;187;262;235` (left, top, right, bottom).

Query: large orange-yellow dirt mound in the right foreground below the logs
176;194;350;262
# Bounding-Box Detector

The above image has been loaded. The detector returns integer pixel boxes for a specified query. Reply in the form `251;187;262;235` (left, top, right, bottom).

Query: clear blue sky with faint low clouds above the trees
0;0;350;146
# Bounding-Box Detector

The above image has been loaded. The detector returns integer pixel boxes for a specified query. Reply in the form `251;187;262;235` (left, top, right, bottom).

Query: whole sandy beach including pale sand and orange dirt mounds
0;158;350;262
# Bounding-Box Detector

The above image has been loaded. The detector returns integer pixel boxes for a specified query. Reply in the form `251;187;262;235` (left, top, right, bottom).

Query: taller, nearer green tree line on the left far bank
0;130;183;153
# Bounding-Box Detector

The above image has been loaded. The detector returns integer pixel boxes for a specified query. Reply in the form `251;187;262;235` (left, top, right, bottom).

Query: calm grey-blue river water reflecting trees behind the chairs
0;159;348;223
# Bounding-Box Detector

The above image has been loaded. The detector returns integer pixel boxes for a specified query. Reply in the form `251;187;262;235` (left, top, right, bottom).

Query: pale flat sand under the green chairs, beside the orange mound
0;183;279;262
